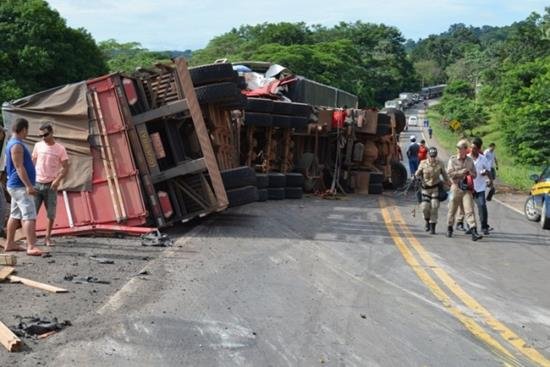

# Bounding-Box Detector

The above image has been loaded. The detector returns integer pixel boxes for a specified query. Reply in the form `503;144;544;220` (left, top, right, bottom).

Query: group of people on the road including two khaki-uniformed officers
407;136;498;241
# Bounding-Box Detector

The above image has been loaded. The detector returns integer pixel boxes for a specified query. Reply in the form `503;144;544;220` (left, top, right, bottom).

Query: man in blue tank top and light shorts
4;118;42;256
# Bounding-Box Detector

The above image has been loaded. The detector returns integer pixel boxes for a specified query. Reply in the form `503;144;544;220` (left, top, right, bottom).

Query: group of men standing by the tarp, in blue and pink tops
2;118;69;256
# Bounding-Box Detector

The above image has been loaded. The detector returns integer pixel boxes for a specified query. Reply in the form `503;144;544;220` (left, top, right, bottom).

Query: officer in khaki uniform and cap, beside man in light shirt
447;139;483;241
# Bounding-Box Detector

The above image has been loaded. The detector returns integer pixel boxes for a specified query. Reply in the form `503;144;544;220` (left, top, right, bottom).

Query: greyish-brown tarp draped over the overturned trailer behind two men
1;82;92;191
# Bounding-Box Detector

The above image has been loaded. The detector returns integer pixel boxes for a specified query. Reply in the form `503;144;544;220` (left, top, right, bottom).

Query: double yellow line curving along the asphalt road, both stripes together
380;198;550;367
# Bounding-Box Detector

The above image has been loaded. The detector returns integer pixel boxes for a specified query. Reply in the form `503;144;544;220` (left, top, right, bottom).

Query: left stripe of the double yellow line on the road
380;198;520;366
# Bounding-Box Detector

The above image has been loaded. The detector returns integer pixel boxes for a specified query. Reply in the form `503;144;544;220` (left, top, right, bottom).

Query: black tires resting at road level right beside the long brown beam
220;166;259;208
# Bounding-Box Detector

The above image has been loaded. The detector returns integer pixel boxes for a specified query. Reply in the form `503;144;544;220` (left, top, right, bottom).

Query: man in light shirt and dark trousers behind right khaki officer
469;143;491;235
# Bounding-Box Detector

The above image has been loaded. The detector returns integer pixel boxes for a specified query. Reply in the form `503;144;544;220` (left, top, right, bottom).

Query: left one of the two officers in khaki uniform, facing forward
415;147;451;234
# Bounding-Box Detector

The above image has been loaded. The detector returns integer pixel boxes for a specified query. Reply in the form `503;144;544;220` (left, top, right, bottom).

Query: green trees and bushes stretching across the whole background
0;0;550;188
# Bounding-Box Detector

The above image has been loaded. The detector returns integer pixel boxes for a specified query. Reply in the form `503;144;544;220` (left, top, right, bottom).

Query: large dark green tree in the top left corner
0;0;107;101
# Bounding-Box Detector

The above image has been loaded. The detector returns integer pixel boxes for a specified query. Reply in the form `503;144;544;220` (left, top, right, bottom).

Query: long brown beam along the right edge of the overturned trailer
176;57;229;210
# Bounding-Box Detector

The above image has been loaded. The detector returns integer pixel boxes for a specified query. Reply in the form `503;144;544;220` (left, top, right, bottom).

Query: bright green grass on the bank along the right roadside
428;109;542;191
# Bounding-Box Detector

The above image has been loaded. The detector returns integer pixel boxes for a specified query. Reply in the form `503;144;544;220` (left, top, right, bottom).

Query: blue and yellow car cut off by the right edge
524;166;550;229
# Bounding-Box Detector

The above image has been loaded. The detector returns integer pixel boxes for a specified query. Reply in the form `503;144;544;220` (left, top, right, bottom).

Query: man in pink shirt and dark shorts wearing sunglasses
32;121;69;246
